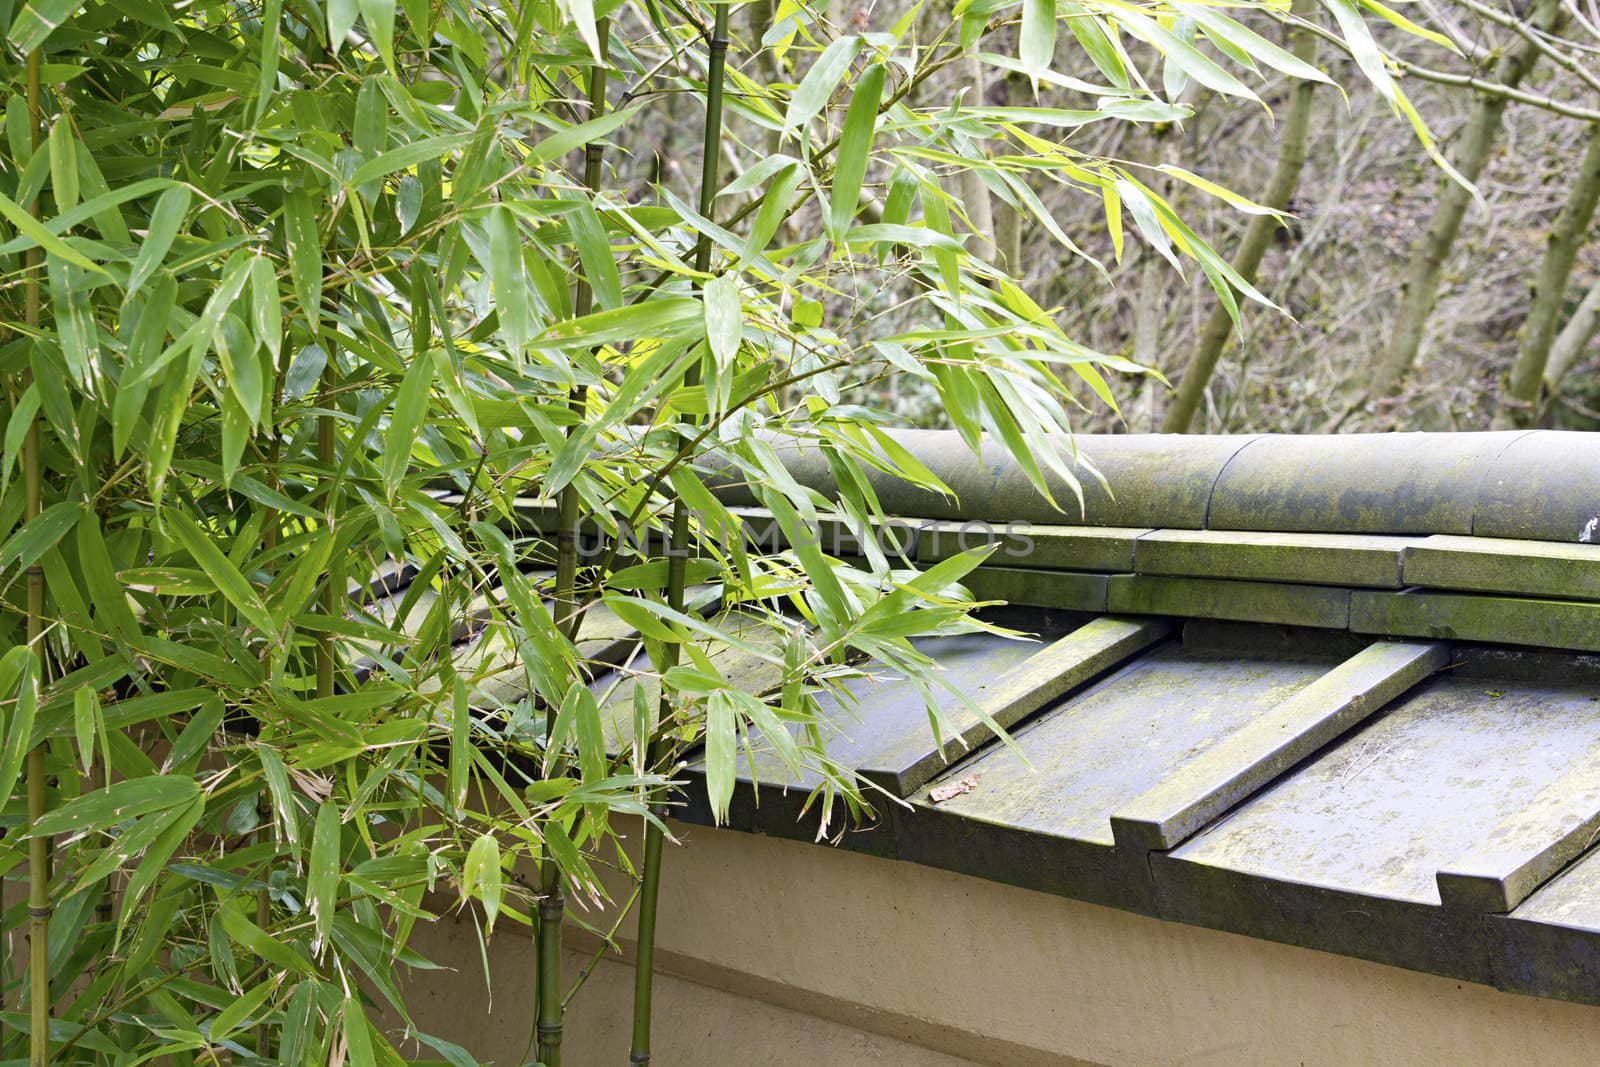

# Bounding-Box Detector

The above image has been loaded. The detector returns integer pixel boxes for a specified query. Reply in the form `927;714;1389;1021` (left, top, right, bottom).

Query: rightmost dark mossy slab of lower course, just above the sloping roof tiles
1350;589;1600;651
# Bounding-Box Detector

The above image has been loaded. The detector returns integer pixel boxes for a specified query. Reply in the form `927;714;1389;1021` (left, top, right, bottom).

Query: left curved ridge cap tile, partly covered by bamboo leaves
732;430;1256;530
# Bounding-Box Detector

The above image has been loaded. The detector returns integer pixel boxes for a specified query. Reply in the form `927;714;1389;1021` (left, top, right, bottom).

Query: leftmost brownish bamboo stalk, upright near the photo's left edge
22;48;51;1067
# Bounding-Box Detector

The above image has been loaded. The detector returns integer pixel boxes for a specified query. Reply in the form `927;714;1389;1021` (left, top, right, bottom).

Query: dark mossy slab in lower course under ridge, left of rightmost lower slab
1106;574;1350;630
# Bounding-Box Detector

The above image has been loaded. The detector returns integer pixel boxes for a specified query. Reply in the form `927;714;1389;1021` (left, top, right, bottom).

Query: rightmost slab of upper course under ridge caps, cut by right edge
1403;534;1600;600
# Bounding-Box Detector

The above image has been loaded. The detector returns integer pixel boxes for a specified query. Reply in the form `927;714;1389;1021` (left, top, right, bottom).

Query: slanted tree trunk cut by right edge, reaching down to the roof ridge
1494;123;1600;429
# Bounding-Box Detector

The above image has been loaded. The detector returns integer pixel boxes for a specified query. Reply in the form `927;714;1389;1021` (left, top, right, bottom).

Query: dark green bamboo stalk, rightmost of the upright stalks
629;0;728;1064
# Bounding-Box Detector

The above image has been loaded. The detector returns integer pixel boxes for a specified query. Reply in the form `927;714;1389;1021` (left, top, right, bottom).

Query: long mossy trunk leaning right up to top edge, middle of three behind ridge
1366;0;1566;400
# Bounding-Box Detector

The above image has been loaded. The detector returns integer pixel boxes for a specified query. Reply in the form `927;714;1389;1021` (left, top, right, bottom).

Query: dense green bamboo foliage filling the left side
0;0;1440;1067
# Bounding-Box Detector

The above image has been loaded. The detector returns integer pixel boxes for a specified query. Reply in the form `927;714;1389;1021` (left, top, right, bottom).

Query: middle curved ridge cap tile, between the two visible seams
1208;430;1523;534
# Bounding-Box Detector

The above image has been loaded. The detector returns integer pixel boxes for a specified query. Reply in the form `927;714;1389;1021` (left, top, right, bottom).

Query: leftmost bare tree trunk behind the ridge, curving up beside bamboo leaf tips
1162;0;1317;434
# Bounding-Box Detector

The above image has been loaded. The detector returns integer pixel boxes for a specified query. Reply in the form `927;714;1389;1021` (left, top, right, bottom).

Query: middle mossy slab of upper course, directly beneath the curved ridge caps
1133;530;1410;589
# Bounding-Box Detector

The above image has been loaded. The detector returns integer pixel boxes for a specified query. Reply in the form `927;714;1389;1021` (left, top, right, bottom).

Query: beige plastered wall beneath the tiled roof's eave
400;825;1600;1067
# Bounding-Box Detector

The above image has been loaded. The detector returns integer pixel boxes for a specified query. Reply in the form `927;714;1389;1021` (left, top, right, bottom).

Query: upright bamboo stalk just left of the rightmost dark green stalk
534;19;611;1067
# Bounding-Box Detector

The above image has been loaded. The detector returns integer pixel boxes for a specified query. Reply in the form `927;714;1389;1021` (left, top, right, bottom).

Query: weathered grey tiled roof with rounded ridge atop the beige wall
438;430;1600;1003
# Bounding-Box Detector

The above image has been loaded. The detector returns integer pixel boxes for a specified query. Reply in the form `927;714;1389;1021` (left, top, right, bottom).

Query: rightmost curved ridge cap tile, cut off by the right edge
1472;430;1600;544
